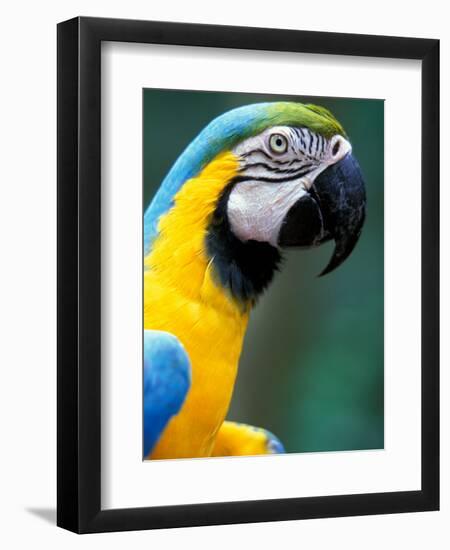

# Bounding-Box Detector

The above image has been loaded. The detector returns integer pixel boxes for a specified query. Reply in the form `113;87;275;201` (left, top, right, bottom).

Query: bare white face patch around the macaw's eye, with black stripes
227;126;351;246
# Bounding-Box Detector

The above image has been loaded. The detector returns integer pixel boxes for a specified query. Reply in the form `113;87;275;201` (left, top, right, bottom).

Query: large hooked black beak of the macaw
278;153;366;275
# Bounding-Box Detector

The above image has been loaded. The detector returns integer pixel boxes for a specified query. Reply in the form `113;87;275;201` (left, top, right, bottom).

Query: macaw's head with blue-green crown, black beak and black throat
146;102;366;302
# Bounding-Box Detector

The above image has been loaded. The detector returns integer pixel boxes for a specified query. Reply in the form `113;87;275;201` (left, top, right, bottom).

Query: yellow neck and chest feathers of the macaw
144;153;249;458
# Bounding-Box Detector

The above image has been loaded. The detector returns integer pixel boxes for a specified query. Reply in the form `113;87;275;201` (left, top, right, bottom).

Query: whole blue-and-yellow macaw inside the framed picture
143;102;366;459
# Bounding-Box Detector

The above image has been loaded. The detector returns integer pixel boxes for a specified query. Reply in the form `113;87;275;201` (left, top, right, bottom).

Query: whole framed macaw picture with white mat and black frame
57;17;439;533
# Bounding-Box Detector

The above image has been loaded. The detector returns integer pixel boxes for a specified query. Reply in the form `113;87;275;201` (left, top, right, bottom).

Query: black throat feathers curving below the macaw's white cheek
206;176;281;305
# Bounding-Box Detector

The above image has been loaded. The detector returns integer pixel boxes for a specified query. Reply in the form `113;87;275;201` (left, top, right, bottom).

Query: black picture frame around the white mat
57;17;439;533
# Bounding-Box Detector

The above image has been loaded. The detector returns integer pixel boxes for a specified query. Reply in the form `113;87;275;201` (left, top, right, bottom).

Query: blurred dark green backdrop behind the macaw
143;89;384;452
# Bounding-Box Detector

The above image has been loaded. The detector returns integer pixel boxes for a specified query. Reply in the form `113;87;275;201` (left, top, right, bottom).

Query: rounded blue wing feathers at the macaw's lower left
143;330;191;458
